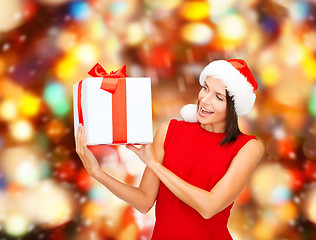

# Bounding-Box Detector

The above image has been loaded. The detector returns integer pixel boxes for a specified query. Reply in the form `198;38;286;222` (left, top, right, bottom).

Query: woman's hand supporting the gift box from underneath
126;143;157;167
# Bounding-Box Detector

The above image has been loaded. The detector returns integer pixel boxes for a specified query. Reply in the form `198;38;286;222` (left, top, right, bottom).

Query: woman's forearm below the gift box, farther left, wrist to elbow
93;170;151;213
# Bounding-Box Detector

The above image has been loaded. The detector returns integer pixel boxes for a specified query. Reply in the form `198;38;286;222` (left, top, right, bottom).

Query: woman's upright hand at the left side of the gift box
75;124;100;177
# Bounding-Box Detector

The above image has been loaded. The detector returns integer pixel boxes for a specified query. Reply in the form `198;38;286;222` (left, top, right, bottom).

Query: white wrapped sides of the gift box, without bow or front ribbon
73;77;153;145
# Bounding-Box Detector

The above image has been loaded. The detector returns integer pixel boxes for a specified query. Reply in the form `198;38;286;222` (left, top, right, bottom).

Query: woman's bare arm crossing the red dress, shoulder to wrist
129;139;263;219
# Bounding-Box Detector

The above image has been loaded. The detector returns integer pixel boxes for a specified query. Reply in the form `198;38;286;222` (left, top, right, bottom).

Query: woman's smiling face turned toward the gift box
197;77;227;132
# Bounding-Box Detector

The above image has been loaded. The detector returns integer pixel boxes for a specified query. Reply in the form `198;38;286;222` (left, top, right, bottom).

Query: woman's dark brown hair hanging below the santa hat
198;90;241;145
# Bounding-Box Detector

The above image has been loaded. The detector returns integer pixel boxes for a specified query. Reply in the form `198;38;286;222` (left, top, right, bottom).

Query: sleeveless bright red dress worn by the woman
152;119;256;240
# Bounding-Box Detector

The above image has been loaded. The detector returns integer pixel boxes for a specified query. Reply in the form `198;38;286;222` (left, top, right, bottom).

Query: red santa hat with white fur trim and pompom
181;59;258;122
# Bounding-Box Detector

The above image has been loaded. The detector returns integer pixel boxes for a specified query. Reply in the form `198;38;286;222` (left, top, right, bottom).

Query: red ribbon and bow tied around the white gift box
78;63;127;143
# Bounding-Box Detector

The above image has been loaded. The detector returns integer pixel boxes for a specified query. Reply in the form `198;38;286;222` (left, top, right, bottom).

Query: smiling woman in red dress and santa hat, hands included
76;59;263;240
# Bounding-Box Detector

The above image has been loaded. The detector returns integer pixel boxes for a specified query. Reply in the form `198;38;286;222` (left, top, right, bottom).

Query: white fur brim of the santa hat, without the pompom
200;60;256;116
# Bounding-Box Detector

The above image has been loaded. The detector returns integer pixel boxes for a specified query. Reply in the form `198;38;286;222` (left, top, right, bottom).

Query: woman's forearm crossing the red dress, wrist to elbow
149;162;213;218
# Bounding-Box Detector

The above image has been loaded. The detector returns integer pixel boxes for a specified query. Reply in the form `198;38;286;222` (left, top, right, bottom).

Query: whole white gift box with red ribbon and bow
73;64;153;145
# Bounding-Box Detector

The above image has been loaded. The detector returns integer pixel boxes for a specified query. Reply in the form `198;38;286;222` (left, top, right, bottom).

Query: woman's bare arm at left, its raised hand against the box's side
75;122;169;213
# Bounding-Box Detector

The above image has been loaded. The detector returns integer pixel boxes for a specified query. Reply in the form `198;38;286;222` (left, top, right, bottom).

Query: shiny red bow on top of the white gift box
88;63;127;94
